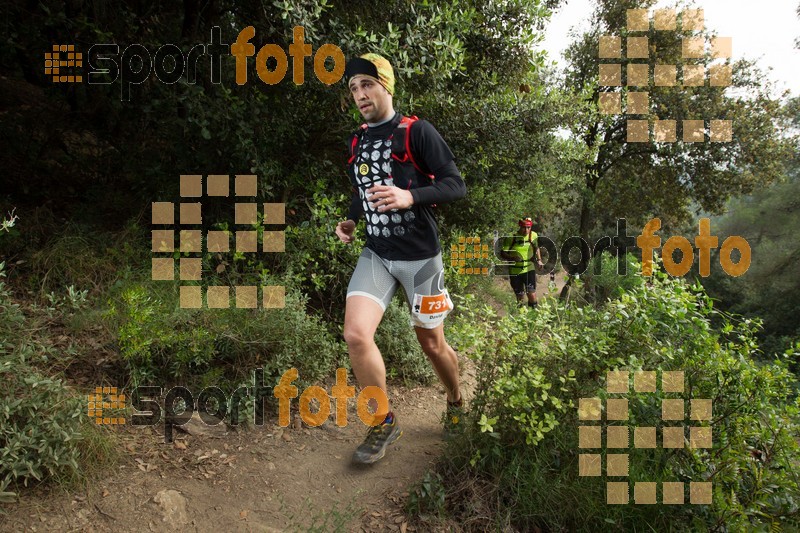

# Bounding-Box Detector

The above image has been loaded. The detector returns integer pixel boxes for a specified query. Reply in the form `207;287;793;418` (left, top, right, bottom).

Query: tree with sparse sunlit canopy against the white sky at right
565;0;789;237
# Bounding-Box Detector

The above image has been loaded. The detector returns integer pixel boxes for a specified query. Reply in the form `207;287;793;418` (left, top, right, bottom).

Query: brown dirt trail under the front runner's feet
0;276;562;531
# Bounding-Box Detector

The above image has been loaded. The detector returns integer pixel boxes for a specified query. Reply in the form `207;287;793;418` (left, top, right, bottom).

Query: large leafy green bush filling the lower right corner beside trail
432;268;800;531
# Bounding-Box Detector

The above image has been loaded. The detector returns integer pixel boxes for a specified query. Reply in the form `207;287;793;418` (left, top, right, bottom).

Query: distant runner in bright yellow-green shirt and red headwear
500;217;544;308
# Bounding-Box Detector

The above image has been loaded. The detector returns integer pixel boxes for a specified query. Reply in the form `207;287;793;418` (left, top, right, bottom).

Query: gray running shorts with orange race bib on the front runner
347;248;453;329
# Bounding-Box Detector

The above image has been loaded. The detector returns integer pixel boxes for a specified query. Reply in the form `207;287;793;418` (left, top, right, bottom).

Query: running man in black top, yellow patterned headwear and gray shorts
336;54;467;464
